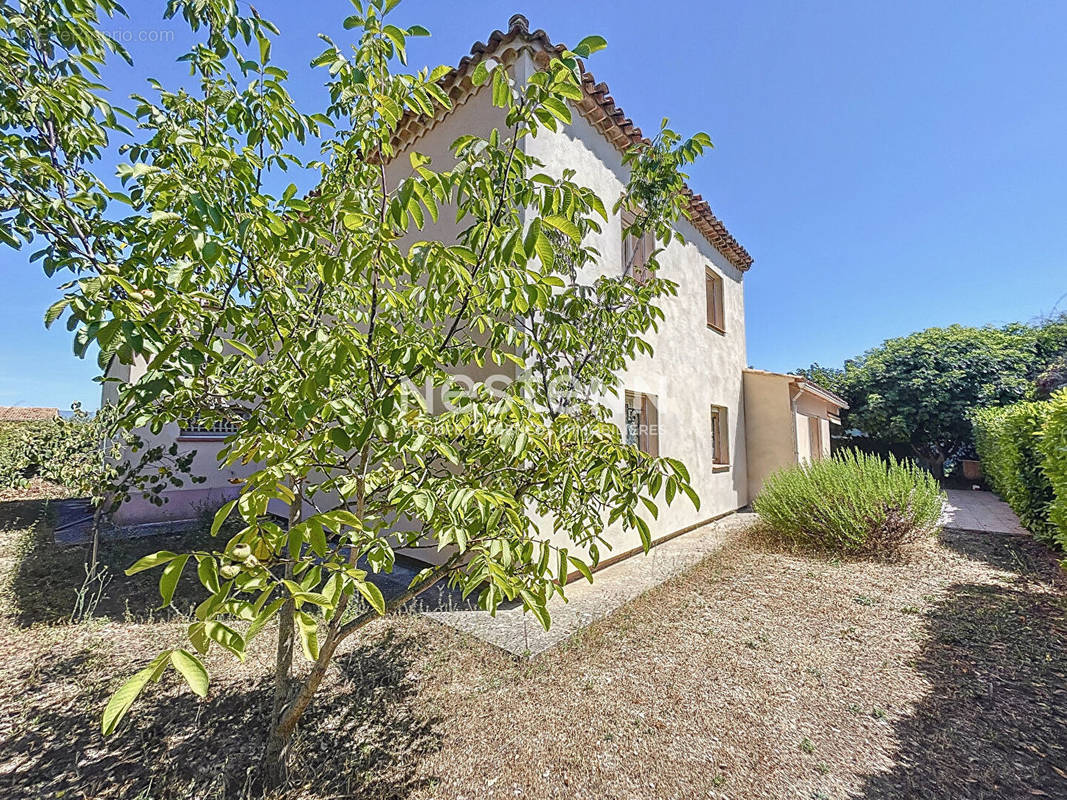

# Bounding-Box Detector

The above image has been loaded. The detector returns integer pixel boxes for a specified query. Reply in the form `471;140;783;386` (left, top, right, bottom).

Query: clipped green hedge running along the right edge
971;390;1067;549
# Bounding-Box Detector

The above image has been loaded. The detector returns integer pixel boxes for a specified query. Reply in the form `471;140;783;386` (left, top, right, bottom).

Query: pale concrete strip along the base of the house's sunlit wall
423;513;754;655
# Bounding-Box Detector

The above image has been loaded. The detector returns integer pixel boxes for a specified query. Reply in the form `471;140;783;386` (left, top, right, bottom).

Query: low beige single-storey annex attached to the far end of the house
745;369;848;497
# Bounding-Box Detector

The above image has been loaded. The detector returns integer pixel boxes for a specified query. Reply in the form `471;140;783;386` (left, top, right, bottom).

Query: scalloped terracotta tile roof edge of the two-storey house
394;14;752;272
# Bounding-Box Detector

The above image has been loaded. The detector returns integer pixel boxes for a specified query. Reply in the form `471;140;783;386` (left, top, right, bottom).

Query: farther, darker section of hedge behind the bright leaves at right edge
971;403;1053;542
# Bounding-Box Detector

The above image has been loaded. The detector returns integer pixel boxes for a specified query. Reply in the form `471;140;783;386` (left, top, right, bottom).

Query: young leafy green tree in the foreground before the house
0;0;710;783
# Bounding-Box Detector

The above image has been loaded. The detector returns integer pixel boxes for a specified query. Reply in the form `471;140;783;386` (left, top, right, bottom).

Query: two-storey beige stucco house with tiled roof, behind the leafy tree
106;15;828;571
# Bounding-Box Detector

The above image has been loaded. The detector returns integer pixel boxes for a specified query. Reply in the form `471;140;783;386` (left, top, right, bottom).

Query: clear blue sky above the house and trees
0;0;1067;407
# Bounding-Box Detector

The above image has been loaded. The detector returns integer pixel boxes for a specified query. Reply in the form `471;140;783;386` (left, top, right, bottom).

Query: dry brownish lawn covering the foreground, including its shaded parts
0;499;1067;800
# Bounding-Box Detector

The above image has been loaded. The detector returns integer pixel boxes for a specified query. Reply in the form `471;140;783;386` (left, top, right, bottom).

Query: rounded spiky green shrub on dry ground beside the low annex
752;450;944;554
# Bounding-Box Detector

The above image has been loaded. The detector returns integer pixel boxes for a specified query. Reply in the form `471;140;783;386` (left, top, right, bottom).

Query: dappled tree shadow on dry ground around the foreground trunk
0;634;441;800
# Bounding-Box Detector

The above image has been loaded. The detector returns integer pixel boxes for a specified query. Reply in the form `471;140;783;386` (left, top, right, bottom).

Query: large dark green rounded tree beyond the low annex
844;325;1035;476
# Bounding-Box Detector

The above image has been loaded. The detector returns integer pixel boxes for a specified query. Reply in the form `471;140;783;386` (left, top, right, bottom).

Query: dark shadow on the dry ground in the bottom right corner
861;576;1067;800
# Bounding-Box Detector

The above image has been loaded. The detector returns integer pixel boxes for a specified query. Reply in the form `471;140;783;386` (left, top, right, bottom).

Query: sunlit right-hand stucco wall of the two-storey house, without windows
526;50;748;558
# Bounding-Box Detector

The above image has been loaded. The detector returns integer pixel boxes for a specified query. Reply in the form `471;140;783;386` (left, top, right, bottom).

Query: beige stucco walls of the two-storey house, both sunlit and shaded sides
110;48;751;558
